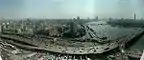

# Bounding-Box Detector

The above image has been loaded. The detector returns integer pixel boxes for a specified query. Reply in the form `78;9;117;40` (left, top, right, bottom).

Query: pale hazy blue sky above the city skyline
0;0;144;18
